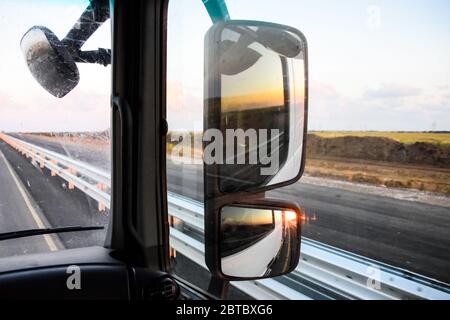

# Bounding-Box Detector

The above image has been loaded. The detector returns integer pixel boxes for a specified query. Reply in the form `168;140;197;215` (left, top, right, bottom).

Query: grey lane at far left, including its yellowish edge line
0;146;57;257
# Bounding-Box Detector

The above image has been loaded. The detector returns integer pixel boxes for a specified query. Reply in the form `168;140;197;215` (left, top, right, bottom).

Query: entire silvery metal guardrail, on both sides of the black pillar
0;134;450;300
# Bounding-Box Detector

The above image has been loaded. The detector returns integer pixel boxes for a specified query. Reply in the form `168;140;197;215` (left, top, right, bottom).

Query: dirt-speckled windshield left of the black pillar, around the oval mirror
0;0;111;257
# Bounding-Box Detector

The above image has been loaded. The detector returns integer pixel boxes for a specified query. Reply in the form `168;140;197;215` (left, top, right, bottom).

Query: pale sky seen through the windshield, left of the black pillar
0;0;111;132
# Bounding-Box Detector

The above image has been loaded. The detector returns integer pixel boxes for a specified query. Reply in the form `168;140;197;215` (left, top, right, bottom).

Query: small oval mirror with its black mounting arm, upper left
20;0;111;98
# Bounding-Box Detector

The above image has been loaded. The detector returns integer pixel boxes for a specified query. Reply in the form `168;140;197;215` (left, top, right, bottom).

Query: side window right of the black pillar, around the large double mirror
167;0;450;298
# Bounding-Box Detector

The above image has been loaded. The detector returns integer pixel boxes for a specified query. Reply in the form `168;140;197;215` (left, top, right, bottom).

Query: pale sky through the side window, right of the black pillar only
168;0;450;131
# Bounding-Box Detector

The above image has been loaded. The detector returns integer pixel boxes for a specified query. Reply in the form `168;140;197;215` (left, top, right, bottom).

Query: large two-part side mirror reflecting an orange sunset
203;20;308;281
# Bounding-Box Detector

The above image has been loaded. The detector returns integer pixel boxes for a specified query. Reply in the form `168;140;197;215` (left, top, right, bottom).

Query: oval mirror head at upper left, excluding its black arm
20;26;80;98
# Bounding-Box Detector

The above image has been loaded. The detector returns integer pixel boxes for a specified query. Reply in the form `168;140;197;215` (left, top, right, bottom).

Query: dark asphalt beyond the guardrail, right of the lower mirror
272;184;450;282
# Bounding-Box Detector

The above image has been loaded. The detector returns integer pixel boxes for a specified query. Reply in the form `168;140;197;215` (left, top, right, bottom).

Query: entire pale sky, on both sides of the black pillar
0;0;450;131
